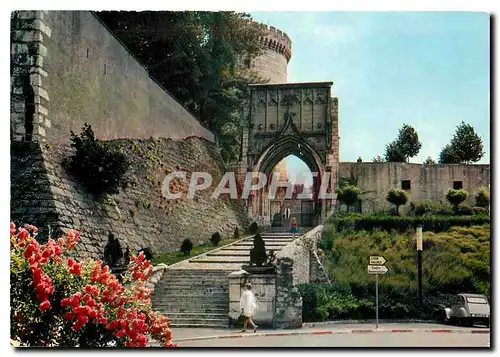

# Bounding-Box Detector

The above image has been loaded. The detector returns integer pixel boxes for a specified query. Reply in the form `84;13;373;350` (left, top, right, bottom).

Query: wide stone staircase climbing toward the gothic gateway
152;233;297;328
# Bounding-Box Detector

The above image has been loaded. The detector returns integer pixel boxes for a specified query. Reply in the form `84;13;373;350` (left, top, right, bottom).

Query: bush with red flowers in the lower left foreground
10;222;176;347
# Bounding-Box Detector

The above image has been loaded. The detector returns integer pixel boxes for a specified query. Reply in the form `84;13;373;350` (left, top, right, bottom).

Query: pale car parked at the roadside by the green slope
444;294;490;327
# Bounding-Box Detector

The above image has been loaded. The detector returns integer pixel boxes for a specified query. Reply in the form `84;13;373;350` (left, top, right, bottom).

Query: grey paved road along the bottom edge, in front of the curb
179;332;490;347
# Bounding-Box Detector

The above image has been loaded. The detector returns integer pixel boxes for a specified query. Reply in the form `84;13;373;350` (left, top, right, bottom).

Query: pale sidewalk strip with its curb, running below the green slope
151;323;490;347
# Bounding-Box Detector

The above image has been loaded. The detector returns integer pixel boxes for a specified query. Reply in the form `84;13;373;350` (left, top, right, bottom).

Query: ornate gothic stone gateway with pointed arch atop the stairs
239;82;339;225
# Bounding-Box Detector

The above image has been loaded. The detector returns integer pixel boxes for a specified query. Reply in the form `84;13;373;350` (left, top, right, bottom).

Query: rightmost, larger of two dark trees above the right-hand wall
439;122;484;164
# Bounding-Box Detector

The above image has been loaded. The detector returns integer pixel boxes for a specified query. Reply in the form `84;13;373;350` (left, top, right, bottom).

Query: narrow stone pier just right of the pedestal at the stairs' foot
274;258;302;328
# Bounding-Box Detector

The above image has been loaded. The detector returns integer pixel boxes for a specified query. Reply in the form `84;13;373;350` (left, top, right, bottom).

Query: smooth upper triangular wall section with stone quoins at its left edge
11;11;215;143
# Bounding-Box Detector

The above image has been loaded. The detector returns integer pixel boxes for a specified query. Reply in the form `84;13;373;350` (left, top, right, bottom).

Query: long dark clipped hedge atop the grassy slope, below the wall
326;215;490;233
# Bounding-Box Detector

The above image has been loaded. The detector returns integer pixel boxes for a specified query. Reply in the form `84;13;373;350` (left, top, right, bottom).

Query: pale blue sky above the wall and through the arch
251;12;490;184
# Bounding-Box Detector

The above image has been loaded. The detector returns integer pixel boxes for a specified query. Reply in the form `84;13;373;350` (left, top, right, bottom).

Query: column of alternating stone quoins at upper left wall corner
10;11;51;141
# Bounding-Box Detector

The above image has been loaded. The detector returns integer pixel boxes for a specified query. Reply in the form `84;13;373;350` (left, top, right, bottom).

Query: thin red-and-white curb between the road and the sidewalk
167;328;490;343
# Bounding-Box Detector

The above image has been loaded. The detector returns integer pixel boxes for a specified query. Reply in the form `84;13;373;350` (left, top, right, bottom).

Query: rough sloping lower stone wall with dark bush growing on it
11;137;248;258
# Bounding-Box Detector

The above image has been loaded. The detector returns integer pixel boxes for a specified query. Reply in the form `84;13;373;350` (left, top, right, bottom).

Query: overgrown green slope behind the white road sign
299;225;490;321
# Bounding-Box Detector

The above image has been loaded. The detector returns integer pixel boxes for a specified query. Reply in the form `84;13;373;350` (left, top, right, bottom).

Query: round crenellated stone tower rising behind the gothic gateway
244;24;292;83
